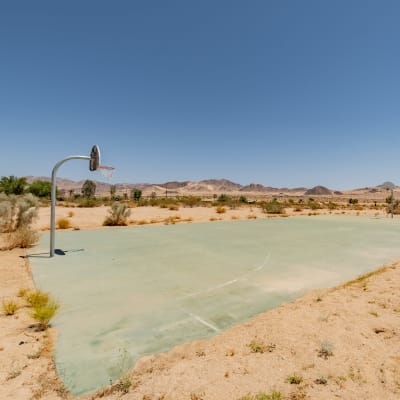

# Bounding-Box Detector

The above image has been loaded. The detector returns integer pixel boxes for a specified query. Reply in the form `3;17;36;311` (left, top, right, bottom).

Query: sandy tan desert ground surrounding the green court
0;207;400;400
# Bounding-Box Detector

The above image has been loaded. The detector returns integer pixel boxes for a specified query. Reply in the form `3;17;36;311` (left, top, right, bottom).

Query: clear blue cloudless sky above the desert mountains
0;0;400;189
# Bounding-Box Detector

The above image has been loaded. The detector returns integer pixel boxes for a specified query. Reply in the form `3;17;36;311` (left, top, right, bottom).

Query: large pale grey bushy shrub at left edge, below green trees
0;193;38;232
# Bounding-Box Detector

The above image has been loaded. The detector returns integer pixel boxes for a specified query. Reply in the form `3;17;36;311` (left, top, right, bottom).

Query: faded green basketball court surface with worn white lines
30;216;400;394
